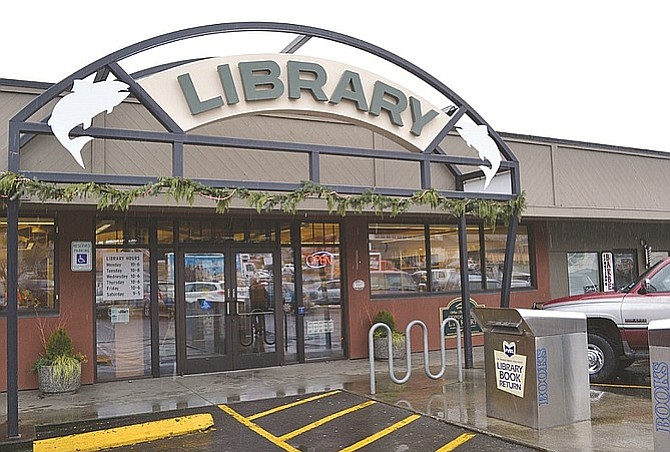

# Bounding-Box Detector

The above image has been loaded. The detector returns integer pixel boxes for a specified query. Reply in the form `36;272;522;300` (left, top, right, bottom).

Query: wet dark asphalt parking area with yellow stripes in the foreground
34;390;537;452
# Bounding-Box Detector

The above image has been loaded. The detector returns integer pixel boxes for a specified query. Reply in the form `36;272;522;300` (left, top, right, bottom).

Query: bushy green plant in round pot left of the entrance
30;326;86;394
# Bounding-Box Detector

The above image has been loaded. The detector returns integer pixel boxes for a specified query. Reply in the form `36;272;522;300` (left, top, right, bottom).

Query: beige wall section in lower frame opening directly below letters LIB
184;146;309;182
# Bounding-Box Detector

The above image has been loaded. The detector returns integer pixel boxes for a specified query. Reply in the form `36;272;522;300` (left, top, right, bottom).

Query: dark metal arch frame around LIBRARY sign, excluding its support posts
8;22;520;196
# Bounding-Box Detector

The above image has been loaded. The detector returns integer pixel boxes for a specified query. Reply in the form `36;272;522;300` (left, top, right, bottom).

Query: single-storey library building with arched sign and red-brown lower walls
0;22;670;391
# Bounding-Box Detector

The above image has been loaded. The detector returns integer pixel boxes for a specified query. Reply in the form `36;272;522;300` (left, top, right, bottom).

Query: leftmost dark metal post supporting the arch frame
7;199;21;438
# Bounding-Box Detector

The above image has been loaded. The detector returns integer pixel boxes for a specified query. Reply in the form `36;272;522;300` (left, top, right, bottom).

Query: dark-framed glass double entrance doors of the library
181;248;281;373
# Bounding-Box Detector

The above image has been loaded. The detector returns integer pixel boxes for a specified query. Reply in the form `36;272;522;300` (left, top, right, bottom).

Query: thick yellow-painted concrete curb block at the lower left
33;413;214;452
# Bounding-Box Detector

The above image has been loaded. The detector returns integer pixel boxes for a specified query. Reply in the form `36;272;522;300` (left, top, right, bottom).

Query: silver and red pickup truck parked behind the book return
535;258;670;383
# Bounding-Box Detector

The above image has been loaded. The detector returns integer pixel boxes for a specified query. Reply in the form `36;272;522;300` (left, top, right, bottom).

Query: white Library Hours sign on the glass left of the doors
102;252;144;301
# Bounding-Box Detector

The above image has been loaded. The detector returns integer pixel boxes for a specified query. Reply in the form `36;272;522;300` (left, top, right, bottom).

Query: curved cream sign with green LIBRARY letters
139;54;450;151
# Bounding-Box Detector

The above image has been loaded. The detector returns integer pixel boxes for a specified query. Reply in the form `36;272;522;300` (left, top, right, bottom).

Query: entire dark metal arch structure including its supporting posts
6;22;521;438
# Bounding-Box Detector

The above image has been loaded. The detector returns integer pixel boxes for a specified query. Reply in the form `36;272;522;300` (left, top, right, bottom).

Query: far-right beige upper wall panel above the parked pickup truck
555;147;670;211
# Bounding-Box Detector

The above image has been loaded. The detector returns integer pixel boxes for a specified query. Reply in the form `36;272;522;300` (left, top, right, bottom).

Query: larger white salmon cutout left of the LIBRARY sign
47;80;130;168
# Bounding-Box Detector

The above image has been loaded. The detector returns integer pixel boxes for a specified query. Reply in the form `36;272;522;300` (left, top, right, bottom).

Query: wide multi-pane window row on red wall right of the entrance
368;224;533;296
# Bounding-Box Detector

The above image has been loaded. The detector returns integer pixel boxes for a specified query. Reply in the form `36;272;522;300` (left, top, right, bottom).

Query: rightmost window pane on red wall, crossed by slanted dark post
484;226;533;289
